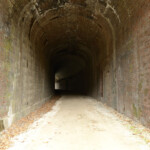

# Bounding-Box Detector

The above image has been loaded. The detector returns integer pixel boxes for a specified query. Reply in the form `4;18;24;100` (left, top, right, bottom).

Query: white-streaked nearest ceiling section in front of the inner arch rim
7;0;146;41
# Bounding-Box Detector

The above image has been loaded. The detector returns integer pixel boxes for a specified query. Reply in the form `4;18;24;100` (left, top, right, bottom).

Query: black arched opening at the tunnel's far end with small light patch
52;48;91;95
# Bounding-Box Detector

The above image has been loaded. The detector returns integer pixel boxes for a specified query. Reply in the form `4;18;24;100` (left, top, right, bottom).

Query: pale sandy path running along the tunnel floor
6;96;150;150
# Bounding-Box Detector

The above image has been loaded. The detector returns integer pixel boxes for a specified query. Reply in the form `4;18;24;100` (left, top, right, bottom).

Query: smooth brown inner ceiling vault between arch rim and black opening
30;6;111;62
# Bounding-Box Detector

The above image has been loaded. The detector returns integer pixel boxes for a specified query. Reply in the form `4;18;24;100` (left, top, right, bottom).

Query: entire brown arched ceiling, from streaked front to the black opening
11;0;146;69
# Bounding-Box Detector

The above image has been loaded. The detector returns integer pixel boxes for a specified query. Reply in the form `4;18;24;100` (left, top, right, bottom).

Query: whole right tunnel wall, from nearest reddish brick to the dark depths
101;1;150;127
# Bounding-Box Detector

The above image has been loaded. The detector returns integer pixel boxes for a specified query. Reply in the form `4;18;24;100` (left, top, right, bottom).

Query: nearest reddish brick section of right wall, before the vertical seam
116;3;150;127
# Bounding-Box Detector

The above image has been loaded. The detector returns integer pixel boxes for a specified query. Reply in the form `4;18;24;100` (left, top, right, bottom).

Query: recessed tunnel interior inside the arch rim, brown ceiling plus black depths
30;5;113;95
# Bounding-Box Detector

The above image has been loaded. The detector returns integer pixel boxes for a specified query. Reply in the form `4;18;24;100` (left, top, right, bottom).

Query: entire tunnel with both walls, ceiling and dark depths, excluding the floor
0;0;150;130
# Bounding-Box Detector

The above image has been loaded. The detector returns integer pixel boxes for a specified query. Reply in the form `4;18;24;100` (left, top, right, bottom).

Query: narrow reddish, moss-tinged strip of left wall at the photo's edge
0;2;12;131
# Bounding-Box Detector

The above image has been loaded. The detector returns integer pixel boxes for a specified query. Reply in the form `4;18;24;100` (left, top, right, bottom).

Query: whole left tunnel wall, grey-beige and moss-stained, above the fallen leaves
0;0;52;131
